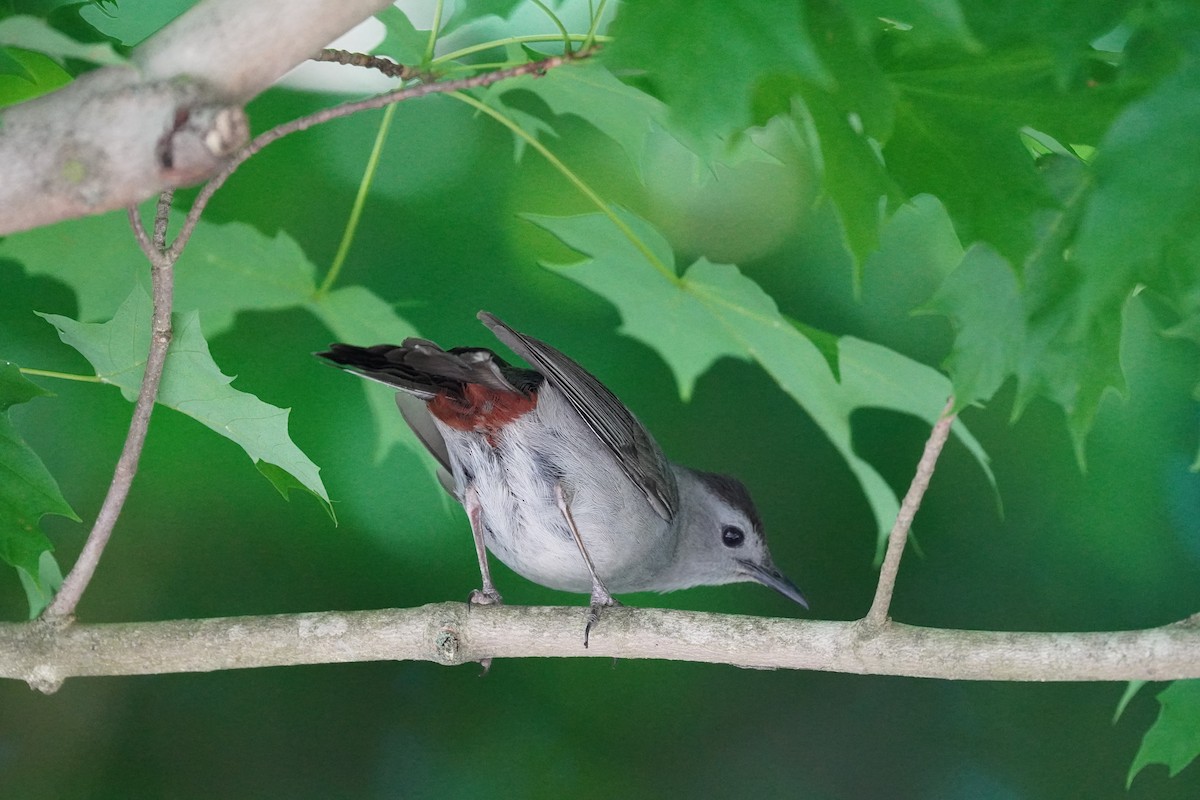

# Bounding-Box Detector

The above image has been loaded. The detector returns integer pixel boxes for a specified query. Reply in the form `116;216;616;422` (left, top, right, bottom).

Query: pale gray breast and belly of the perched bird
438;386;674;593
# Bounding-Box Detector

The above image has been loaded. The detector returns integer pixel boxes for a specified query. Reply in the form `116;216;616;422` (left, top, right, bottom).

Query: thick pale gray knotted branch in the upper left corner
0;0;390;235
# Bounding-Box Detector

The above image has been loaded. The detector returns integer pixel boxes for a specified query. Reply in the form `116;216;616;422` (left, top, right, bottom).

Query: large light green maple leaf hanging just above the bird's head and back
526;210;991;551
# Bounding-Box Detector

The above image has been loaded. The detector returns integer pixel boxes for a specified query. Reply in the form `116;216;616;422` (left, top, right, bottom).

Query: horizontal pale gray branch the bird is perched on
0;603;1200;692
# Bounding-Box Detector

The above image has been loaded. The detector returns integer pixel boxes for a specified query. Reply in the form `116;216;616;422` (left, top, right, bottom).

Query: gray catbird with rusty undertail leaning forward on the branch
317;312;808;644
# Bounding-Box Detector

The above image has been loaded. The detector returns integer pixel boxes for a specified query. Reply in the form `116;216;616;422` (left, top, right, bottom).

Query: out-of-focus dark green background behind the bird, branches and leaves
0;3;1200;800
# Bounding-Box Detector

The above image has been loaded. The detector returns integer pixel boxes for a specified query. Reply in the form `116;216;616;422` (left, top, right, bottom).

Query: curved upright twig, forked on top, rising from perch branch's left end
42;199;176;620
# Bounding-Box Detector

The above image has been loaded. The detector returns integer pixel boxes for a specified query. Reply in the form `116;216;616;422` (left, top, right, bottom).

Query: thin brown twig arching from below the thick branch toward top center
169;48;596;258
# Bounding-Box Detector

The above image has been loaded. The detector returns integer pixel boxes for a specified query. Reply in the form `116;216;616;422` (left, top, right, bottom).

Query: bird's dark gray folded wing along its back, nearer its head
479;311;679;522
